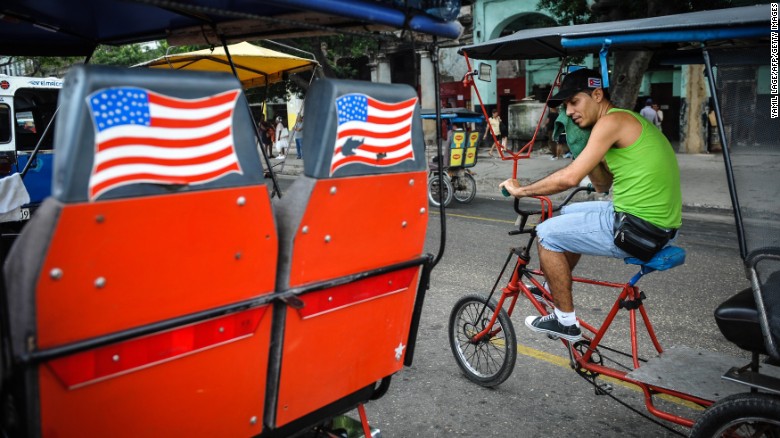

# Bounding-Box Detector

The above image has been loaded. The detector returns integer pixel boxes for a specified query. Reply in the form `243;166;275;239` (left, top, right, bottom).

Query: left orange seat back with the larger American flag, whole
4;67;278;436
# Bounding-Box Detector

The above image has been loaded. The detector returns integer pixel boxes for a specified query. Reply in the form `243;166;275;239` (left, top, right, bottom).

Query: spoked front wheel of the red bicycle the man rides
449;295;517;388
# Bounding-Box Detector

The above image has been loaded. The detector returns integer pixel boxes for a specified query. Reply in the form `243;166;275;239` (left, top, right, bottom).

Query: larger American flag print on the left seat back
87;87;242;200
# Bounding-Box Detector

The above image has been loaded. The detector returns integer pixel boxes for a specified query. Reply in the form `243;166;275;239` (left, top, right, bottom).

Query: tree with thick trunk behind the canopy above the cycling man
538;0;740;108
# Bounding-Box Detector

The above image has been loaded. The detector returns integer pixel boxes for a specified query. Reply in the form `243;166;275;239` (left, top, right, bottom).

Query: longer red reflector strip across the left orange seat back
47;306;268;389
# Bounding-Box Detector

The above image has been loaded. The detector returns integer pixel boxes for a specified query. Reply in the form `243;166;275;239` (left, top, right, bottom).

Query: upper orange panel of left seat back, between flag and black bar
36;186;277;348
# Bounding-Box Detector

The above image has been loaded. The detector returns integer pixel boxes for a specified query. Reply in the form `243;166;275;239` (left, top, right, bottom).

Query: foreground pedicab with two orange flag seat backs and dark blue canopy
0;0;462;437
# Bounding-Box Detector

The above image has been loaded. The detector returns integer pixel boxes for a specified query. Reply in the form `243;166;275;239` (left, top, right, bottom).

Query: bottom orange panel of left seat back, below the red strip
39;309;272;438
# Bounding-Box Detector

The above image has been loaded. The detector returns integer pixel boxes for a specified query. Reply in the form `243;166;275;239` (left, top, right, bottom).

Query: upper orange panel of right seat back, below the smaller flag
290;172;428;286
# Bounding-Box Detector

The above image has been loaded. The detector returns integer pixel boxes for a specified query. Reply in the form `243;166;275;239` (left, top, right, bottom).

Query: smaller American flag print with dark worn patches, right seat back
330;93;417;175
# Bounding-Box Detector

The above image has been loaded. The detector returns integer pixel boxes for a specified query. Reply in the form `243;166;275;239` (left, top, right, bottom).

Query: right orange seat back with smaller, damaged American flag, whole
267;79;428;425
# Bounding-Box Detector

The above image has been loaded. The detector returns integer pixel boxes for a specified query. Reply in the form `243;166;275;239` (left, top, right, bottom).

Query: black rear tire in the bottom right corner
691;393;780;438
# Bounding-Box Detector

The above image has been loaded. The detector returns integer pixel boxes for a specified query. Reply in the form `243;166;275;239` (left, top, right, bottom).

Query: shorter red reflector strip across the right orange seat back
298;266;419;319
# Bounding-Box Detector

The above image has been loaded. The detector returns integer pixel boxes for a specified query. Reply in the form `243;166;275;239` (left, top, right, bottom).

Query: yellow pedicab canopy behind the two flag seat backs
135;42;319;88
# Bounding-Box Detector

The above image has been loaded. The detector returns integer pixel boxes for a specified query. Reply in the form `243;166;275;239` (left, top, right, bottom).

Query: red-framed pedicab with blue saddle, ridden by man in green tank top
450;5;780;437
